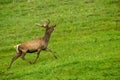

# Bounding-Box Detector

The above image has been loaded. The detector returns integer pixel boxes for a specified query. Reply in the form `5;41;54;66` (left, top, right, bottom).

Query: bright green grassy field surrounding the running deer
0;0;120;80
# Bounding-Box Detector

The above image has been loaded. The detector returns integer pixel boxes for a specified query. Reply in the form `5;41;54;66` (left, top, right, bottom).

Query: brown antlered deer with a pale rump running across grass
7;20;57;69
